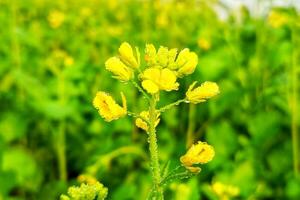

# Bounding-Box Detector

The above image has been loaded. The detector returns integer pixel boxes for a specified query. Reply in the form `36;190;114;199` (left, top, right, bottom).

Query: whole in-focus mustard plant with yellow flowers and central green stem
93;42;219;200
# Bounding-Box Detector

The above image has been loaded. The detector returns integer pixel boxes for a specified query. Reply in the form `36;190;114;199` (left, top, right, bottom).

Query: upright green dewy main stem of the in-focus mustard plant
148;96;164;200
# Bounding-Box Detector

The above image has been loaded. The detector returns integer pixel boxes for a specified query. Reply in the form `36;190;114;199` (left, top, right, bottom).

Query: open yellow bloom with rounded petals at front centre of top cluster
141;67;179;94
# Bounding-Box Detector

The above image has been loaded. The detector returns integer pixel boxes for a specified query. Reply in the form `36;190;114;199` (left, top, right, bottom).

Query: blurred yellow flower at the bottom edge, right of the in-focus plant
211;181;240;200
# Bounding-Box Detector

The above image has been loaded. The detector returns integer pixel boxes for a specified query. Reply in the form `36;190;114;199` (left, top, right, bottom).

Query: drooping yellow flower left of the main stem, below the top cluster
93;91;127;122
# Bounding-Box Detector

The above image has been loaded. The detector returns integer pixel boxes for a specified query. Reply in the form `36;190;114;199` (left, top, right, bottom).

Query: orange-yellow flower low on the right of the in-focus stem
180;141;215;173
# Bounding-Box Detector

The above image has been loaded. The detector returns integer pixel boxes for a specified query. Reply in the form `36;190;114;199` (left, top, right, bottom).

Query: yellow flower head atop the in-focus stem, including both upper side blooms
93;42;219;122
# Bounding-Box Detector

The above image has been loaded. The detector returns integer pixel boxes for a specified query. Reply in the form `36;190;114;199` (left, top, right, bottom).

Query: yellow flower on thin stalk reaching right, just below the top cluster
186;81;220;104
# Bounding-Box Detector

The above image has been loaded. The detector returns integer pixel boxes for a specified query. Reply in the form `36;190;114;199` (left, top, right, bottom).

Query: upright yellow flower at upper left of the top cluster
119;42;140;69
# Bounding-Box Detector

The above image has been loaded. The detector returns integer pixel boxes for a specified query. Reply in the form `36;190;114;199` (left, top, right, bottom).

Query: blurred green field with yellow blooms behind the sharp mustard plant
0;0;300;200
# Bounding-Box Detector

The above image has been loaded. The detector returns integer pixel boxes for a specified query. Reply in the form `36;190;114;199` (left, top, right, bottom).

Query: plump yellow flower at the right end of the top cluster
176;48;198;77
